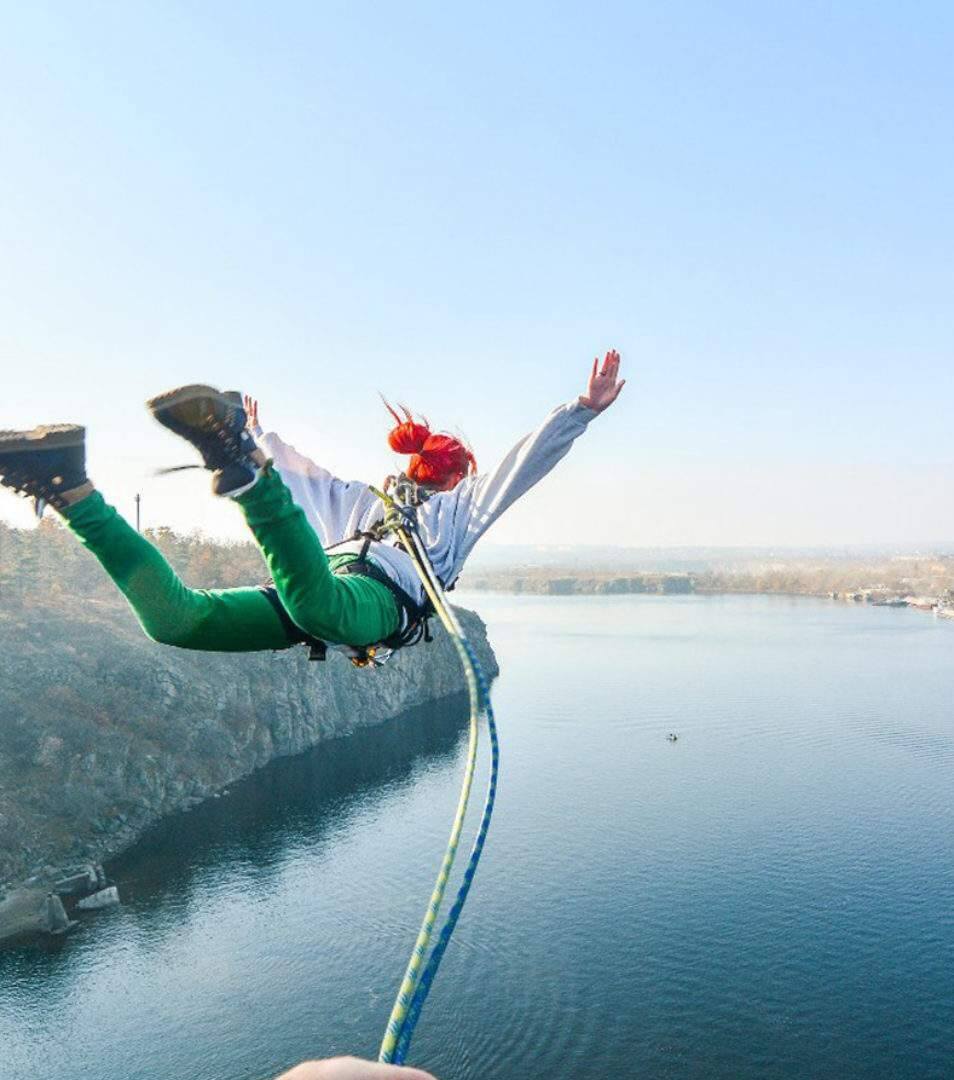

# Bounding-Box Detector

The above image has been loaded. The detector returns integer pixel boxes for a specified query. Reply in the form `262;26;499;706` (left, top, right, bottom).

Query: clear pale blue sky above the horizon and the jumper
0;2;954;544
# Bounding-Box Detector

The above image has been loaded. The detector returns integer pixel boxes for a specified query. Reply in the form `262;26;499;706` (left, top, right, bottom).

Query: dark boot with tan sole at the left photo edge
0;423;86;516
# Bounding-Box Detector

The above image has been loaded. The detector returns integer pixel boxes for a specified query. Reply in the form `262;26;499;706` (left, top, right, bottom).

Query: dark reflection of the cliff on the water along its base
0;694;469;980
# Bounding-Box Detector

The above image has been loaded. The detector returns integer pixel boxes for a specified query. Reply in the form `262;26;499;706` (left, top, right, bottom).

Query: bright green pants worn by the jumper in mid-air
64;467;400;652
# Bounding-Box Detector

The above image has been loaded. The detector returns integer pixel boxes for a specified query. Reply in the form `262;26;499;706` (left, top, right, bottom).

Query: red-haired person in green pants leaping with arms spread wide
0;351;624;663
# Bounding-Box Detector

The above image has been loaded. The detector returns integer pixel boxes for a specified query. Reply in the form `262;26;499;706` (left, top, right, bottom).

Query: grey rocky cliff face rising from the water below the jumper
0;598;497;899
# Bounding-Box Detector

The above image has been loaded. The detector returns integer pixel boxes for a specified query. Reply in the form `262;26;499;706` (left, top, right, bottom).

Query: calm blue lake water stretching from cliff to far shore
0;595;954;1080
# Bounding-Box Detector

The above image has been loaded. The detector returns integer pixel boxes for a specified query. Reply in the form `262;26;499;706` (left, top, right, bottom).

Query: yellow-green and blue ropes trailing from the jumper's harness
372;488;499;1065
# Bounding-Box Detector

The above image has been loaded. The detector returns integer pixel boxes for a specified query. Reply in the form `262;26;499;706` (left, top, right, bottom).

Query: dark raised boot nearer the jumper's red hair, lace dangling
146;386;258;495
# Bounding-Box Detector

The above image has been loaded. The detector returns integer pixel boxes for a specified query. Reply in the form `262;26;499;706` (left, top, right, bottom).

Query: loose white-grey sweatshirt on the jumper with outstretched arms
252;401;596;603
